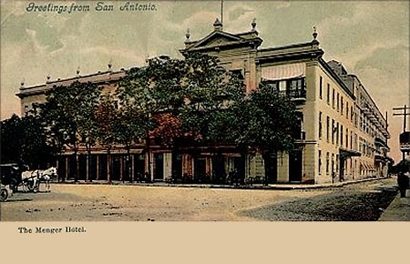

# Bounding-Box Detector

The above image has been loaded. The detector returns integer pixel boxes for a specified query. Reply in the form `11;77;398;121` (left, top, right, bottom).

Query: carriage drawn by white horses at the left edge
0;163;57;200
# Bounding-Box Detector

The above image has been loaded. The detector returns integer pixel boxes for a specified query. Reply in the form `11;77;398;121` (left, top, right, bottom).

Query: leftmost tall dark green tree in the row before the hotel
40;81;101;181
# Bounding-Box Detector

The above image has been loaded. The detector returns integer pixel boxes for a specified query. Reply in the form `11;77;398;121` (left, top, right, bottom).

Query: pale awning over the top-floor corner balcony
261;63;306;81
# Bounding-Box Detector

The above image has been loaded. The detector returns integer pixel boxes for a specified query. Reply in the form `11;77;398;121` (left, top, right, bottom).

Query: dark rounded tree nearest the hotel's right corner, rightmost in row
234;83;301;182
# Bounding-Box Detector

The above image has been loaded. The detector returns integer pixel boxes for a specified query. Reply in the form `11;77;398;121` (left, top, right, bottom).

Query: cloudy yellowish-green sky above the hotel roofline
0;0;410;161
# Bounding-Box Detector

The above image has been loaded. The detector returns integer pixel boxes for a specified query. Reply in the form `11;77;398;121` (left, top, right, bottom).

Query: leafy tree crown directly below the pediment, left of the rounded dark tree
180;53;245;144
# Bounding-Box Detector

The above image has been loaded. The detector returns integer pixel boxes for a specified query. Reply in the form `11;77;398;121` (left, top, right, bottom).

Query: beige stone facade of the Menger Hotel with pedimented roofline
18;21;390;183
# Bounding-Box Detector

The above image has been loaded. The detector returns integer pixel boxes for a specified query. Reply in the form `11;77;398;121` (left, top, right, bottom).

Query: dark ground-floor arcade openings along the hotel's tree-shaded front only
53;152;302;183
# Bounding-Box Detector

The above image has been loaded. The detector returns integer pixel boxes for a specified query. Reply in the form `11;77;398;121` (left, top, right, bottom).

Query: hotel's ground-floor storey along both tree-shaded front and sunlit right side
57;149;387;184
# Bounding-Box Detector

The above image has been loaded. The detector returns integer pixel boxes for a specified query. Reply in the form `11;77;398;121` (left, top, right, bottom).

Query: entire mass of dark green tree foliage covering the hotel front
2;53;299;184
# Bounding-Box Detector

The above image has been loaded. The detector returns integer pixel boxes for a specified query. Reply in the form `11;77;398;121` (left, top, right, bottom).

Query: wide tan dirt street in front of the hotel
0;179;394;221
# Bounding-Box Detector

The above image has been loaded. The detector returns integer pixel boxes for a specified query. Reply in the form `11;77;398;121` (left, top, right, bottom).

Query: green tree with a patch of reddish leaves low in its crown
117;56;185;179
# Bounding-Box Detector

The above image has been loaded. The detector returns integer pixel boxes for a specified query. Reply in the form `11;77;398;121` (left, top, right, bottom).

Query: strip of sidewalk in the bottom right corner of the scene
379;190;410;221
